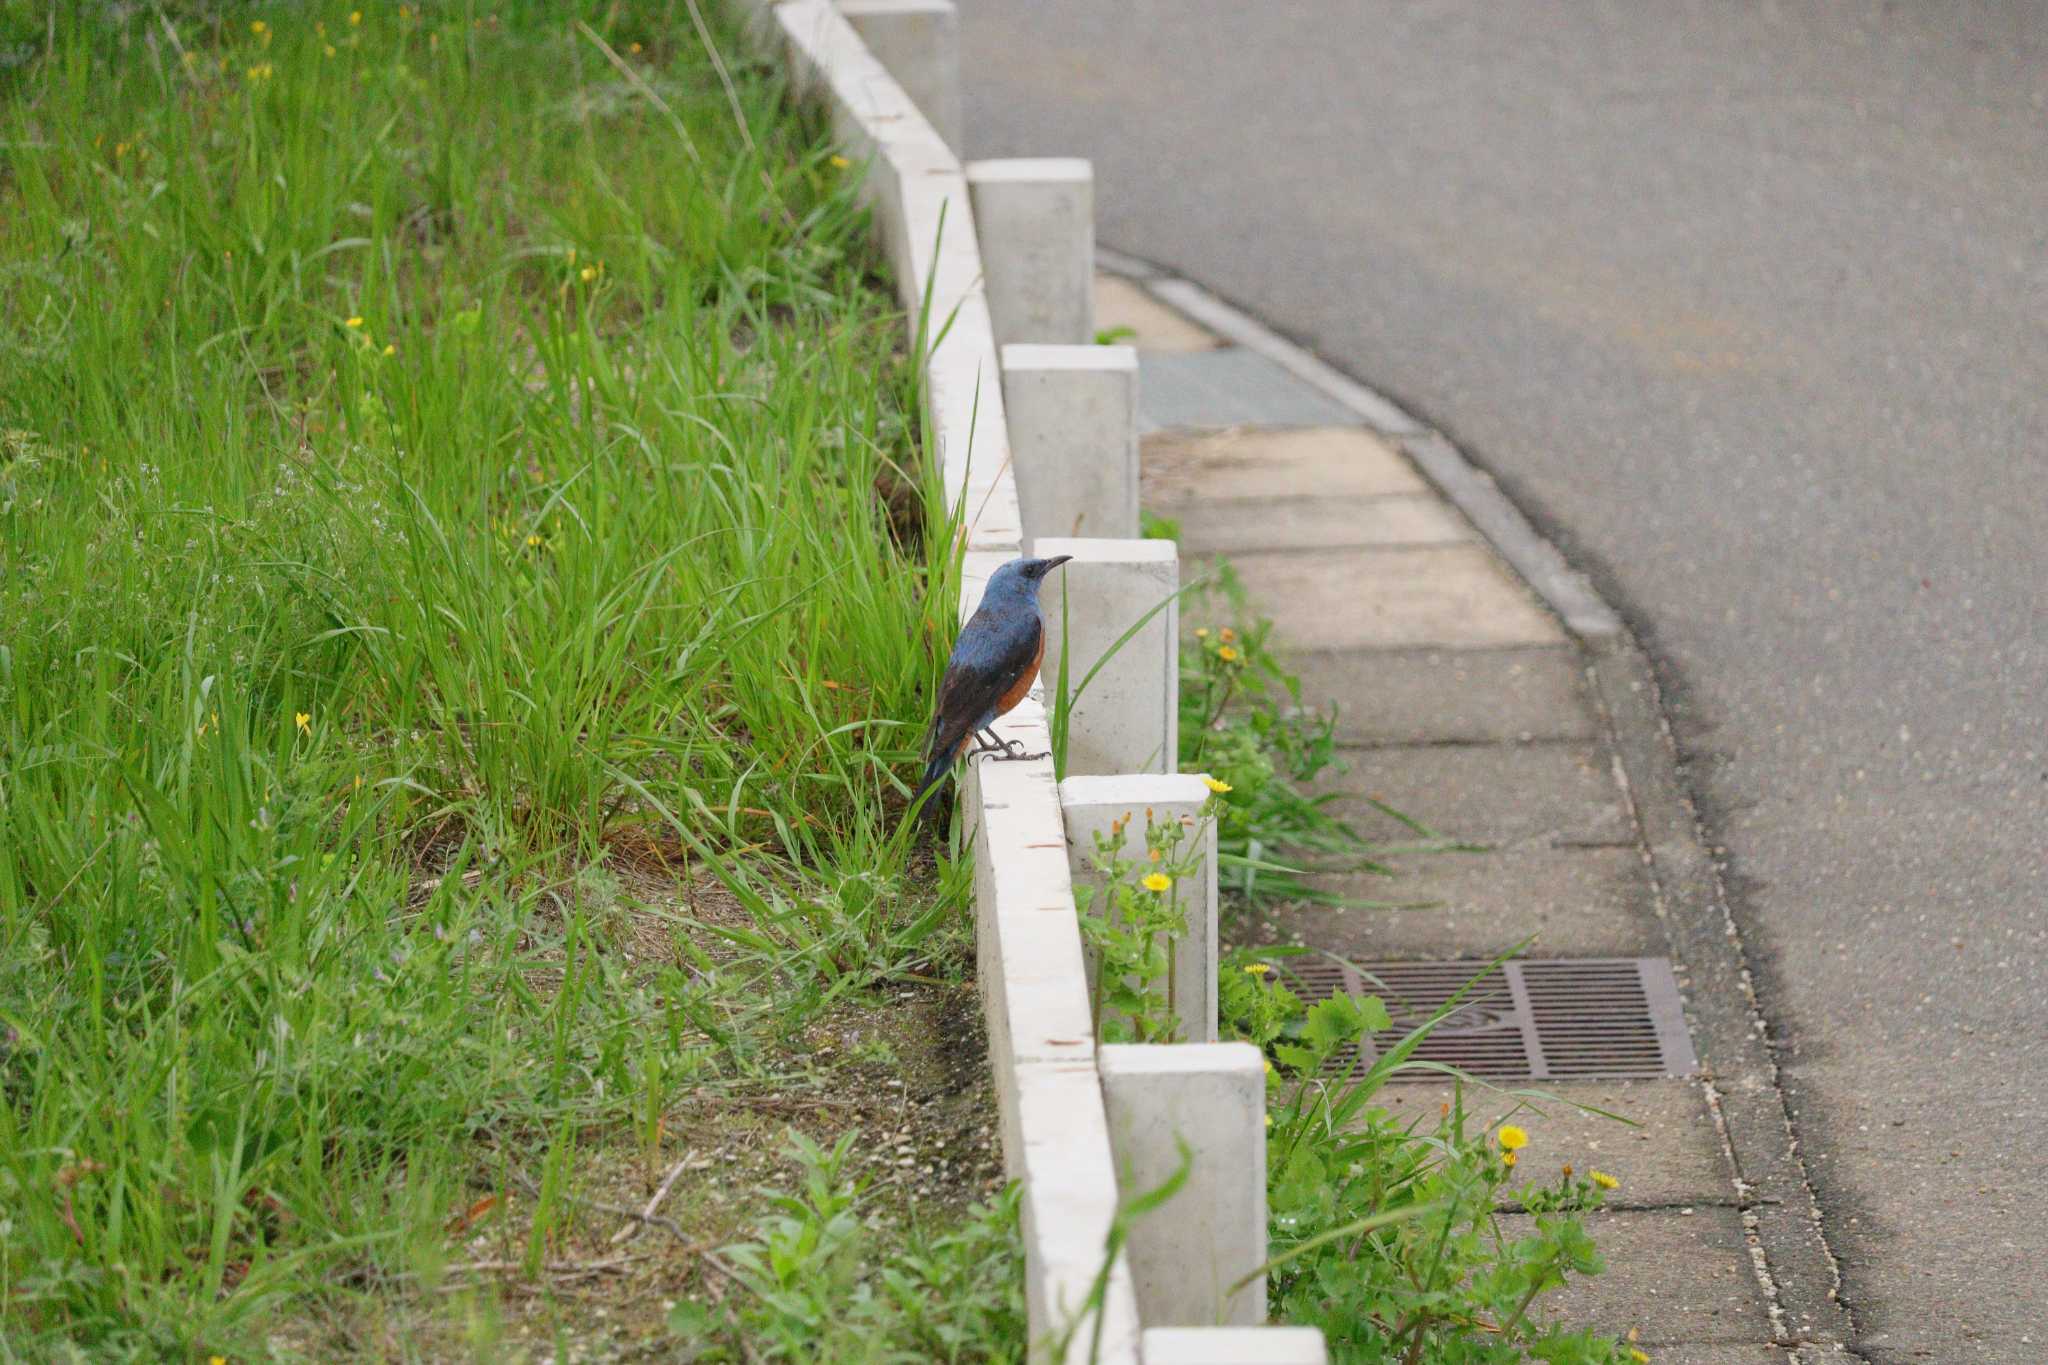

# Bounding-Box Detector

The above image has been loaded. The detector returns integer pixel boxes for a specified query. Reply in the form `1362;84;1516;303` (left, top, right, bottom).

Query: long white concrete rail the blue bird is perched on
743;0;1139;1363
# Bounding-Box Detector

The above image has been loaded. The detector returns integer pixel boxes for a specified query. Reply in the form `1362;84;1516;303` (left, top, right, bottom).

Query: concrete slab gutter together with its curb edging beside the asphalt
1098;250;1855;1365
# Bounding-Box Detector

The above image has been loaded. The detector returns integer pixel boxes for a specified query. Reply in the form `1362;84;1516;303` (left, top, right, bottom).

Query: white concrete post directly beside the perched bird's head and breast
1030;536;1180;776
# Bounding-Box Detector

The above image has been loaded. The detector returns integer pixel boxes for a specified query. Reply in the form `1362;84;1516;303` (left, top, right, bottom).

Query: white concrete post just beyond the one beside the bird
1004;342;1139;536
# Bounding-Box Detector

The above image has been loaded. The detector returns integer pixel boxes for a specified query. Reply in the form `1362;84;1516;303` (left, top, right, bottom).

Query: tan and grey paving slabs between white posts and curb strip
1096;276;1821;1365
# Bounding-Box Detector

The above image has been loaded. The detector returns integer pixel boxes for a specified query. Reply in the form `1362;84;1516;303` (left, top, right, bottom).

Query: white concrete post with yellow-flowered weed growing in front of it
1059;774;1217;1044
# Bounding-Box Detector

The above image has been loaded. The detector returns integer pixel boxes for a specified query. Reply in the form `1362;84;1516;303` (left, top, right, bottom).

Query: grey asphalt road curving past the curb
963;0;2048;1365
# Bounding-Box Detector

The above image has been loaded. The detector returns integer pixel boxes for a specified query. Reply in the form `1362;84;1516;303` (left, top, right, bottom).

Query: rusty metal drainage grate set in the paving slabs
1274;958;1698;1081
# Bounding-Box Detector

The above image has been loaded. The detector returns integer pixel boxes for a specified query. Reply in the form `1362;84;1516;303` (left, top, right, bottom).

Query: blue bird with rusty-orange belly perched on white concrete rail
909;555;1073;808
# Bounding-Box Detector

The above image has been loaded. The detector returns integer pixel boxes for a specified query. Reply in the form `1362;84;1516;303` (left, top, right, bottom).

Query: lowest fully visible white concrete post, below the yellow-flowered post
1096;1044;1266;1326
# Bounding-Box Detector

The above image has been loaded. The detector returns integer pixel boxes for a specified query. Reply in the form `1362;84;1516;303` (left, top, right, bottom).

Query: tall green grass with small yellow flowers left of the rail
0;0;983;1359
